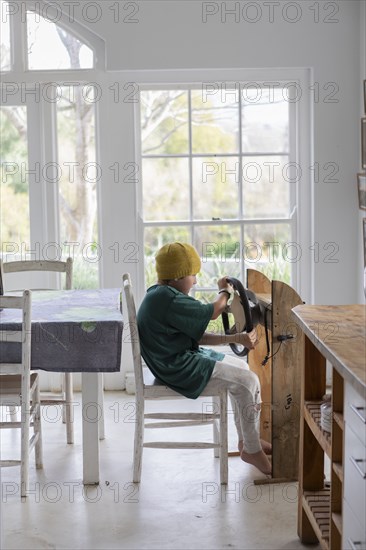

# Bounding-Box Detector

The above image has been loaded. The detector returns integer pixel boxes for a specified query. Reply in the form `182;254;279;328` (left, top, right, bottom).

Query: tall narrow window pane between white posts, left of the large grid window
57;86;100;288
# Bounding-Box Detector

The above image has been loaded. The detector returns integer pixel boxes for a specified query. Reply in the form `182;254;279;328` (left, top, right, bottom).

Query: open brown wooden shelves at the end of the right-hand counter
298;340;344;550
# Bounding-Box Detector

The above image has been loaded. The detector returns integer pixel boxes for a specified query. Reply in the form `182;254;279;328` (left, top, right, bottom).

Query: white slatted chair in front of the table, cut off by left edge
0;290;42;497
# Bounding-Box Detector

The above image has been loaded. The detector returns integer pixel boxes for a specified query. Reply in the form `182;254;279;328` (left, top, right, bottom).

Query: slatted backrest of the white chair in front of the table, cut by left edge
0;290;32;386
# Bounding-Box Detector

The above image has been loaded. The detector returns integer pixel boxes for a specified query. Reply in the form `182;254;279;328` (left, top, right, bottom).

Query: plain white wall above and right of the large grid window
64;0;365;304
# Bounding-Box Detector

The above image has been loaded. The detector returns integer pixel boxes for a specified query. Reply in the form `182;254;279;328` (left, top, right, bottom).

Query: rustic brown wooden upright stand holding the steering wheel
247;270;304;482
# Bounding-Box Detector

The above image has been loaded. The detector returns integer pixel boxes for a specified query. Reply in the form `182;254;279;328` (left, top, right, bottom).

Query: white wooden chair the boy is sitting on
123;273;228;484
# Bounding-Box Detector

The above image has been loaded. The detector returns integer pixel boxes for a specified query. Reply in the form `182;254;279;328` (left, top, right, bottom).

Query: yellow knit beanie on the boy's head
155;242;201;281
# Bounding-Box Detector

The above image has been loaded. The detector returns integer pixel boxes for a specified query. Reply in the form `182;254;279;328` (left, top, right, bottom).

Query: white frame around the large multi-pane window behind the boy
128;68;314;303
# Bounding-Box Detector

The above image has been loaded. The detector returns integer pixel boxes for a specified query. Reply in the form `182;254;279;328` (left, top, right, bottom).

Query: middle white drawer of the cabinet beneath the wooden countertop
344;425;366;525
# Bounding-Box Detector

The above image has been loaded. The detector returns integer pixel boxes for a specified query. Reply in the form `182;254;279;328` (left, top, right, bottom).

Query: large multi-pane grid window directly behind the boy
140;83;297;299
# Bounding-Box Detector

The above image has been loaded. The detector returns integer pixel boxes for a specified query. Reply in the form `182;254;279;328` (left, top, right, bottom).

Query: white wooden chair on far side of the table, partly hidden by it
0;258;74;443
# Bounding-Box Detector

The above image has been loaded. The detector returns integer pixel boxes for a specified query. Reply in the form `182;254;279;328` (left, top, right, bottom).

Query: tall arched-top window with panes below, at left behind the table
0;1;105;287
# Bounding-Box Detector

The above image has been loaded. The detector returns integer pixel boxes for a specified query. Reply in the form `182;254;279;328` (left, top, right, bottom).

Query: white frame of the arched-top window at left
0;0;106;276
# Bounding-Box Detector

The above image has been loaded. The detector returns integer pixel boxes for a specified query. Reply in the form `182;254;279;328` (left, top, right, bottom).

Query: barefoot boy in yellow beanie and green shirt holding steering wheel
137;242;271;474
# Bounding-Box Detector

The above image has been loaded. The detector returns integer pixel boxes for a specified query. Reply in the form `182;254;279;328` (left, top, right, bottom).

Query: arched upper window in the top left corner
0;0;105;71
